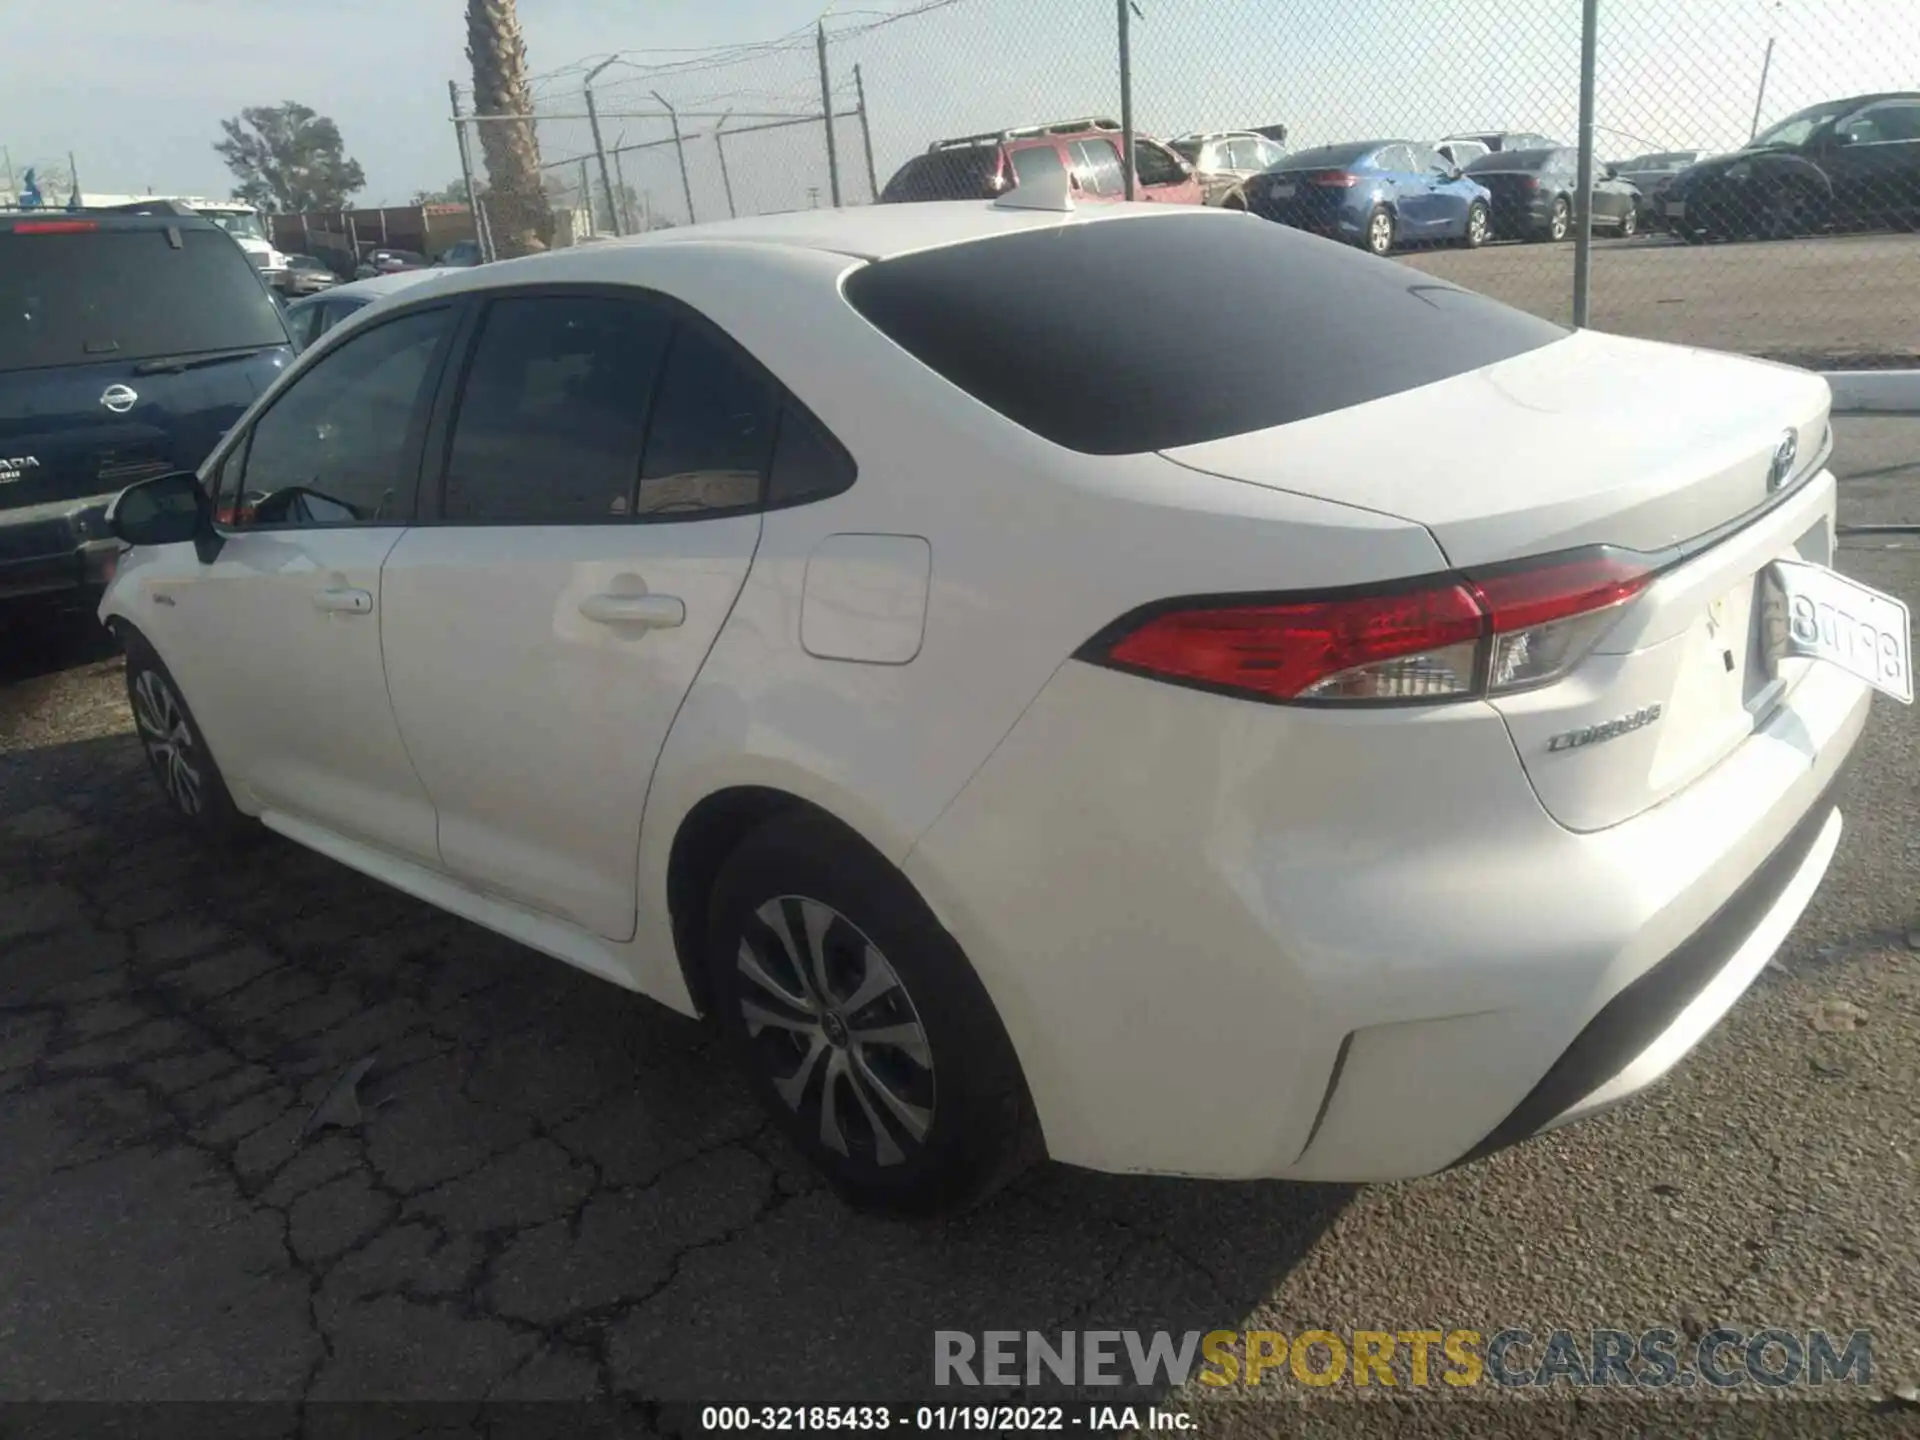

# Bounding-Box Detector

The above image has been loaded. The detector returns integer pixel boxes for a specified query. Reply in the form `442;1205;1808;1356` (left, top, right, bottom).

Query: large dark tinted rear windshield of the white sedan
845;211;1567;455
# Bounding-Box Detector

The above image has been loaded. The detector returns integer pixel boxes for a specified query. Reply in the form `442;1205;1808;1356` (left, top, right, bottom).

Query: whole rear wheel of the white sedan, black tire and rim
707;812;1039;1215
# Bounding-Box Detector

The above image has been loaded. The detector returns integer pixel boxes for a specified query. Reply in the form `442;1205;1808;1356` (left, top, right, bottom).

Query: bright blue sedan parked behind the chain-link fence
1229;140;1494;255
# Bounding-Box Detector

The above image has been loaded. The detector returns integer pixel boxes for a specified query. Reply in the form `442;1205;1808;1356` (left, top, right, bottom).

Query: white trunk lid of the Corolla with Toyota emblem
1164;330;1834;829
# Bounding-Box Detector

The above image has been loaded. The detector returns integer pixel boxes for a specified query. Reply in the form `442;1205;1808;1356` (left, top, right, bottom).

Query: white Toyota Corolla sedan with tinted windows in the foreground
102;192;1910;1210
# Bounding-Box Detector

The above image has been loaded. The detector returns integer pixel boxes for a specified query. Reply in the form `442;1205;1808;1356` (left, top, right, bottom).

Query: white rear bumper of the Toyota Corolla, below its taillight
906;664;1868;1181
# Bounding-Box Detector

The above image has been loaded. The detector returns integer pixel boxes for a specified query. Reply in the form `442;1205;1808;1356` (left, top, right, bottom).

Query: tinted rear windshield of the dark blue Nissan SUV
0;227;286;371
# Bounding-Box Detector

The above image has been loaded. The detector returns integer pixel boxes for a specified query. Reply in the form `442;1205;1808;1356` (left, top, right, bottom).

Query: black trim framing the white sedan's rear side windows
413;280;860;530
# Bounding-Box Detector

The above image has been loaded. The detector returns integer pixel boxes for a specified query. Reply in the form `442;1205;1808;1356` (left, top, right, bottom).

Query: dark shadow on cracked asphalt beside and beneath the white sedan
0;735;1346;1425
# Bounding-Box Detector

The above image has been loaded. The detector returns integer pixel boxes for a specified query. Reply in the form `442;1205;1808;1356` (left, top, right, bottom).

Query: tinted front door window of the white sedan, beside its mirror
234;307;453;526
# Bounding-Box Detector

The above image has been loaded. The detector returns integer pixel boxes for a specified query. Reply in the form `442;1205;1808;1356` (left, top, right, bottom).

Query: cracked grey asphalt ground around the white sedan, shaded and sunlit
0;420;1920;1432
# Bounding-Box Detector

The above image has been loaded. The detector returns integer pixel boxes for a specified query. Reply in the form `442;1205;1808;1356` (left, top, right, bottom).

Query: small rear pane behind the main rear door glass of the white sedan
636;321;774;516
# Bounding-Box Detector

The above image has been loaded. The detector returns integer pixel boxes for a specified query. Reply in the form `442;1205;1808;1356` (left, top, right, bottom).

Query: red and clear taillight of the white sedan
1081;549;1655;701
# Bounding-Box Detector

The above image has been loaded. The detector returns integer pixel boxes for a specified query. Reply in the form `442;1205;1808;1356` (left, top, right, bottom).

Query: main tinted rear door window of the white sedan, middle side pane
444;296;672;524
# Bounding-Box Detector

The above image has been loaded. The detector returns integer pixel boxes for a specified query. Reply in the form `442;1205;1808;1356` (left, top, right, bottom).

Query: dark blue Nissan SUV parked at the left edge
0;204;294;603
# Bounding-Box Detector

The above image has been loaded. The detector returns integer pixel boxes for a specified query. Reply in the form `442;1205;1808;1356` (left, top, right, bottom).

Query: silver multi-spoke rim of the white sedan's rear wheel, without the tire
735;895;935;1167
